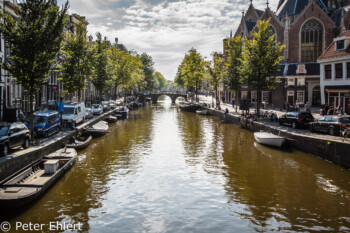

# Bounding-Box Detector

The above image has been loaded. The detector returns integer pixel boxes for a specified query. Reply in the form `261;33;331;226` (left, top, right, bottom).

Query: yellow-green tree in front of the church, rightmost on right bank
240;19;284;116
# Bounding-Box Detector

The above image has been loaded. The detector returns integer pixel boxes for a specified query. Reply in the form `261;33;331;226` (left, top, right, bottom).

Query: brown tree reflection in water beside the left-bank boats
7;108;153;231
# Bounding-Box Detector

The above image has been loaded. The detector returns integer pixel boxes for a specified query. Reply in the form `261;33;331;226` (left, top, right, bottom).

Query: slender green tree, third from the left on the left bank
92;32;110;95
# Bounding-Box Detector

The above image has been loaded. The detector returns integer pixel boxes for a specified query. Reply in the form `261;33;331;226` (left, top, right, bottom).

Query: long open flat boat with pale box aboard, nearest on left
0;148;77;208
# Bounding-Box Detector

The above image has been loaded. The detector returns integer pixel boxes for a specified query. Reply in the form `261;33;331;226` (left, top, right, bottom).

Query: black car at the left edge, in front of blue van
0;122;30;156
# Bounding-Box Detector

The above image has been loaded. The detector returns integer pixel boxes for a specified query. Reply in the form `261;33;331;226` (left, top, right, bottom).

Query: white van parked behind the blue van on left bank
62;102;85;124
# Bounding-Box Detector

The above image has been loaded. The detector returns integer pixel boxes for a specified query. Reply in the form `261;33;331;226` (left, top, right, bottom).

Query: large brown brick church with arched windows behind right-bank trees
221;0;350;107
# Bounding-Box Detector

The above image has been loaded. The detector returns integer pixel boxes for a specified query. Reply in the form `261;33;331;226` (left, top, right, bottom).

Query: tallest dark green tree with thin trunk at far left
0;0;68;135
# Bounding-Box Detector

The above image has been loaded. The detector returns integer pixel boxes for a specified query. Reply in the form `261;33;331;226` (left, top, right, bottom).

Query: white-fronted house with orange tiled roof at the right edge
318;31;350;114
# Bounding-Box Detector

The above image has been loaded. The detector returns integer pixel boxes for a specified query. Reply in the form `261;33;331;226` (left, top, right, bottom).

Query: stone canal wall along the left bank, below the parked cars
0;110;113;181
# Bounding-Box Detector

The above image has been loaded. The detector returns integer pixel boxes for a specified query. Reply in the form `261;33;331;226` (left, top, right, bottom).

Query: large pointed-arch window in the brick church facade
301;20;323;62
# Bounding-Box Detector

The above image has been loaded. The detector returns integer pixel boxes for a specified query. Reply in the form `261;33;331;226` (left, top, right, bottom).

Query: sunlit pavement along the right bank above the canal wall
199;95;320;119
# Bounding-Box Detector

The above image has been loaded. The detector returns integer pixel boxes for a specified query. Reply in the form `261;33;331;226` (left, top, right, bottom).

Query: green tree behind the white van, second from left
59;21;93;102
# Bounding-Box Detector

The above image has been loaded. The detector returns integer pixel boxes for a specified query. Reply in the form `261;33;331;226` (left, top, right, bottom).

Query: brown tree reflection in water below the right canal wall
223;126;350;231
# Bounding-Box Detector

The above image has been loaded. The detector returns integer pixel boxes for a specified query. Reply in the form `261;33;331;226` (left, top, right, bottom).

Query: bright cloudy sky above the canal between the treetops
57;0;278;80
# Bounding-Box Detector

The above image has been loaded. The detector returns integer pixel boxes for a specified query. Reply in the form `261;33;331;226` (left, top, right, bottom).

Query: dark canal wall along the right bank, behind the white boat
208;109;350;169
